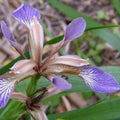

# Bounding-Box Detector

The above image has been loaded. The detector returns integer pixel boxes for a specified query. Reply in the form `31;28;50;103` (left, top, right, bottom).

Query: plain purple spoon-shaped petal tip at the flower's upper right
64;18;86;43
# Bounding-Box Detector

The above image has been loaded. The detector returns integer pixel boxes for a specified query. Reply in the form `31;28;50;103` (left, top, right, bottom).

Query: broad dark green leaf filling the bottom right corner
48;98;120;120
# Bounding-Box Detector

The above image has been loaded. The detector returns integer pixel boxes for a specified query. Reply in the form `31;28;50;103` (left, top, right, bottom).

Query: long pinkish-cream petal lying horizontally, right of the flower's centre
47;55;89;67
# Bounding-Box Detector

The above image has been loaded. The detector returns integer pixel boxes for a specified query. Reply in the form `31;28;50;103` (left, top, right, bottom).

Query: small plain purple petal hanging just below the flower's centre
50;76;72;90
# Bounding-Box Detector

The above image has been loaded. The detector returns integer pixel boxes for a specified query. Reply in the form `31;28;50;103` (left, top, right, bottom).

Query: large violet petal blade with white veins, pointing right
80;66;120;93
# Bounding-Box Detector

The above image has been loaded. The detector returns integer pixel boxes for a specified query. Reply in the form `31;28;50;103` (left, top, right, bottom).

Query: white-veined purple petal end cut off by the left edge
0;77;14;109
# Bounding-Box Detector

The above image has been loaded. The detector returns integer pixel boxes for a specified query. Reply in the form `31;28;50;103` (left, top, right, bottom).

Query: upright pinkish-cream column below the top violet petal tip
29;17;44;66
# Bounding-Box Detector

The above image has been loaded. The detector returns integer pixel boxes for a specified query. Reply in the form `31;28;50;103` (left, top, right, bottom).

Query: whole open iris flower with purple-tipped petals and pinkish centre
0;3;120;108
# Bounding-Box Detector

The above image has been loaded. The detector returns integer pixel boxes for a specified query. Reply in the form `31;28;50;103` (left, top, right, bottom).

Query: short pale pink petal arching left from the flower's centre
10;59;37;74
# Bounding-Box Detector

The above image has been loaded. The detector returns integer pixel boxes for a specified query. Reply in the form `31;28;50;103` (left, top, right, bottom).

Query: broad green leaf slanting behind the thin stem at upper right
47;0;120;51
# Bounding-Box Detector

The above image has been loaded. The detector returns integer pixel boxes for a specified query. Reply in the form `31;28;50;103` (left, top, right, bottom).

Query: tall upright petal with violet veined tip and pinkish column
13;3;44;66
